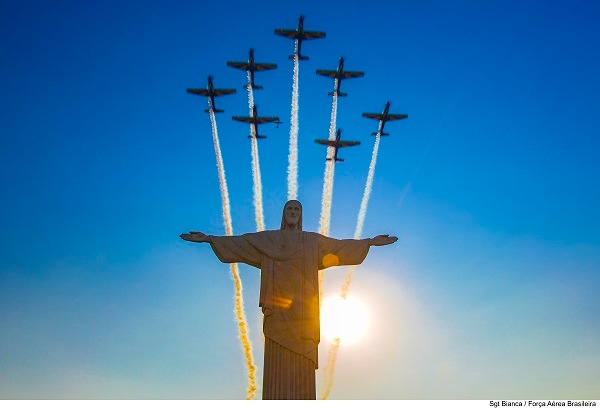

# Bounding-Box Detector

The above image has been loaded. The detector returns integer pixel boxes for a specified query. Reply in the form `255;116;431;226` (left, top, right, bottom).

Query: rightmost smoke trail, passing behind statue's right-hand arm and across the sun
321;131;381;399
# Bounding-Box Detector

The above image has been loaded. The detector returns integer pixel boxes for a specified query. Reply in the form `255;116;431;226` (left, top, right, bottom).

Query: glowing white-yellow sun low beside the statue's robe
321;296;370;344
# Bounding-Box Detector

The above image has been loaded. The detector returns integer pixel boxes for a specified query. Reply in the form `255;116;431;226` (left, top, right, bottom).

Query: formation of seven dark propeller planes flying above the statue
187;16;408;159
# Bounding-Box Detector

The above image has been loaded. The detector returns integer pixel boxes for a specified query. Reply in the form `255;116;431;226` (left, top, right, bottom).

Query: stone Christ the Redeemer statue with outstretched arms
181;200;398;399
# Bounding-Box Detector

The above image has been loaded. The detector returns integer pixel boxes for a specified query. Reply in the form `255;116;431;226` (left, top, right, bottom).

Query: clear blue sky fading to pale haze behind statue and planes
0;0;600;399
